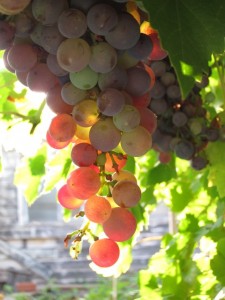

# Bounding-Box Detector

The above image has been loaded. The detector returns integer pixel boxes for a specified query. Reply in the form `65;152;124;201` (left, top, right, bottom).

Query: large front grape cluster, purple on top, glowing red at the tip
0;0;160;267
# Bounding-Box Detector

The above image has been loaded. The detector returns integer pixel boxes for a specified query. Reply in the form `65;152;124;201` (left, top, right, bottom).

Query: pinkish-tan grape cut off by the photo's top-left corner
0;0;31;15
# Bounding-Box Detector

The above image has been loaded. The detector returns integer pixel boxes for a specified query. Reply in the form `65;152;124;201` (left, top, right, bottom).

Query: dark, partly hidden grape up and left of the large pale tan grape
41;24;65;55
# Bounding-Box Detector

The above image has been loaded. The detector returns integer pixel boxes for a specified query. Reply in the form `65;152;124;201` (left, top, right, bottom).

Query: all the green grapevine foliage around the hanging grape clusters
0;0;225;300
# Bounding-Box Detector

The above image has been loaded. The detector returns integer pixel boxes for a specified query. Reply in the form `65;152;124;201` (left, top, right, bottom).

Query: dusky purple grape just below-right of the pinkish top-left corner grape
14;11;35;38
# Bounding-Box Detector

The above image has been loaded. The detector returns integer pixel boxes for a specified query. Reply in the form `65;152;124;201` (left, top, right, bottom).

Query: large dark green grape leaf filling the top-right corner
143;0;225;97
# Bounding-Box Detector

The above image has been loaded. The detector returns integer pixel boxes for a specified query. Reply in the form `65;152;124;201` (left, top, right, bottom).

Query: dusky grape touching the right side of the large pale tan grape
89;42;117;73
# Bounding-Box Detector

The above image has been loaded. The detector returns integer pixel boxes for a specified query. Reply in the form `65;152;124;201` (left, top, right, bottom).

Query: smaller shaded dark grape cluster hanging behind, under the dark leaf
149;57;220;170
